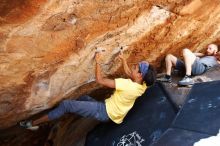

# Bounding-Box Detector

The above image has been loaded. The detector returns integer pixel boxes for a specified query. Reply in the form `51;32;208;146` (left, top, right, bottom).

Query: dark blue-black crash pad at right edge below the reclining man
172;81;220;135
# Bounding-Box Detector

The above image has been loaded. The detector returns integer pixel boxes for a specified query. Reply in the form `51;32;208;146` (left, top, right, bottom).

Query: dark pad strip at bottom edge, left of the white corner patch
150;128;210;146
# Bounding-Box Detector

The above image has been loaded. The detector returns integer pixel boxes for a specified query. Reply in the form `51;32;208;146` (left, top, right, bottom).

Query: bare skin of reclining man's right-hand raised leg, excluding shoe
183;49;196;76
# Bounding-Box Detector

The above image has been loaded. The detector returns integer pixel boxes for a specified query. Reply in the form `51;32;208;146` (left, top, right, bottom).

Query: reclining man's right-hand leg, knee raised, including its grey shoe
179;49;196;86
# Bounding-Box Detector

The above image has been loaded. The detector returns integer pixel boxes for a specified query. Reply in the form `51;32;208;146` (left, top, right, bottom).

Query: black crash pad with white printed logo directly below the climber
85;84;176;146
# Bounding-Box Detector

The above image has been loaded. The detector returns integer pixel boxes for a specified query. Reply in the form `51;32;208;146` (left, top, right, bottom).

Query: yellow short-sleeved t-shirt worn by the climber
105;78;147;124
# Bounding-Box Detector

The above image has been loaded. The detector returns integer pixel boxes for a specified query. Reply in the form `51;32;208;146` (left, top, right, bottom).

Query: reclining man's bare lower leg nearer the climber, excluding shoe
165;54;177;76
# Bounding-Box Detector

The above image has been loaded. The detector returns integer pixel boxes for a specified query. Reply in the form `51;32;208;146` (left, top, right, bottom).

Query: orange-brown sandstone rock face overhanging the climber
0;0;220;129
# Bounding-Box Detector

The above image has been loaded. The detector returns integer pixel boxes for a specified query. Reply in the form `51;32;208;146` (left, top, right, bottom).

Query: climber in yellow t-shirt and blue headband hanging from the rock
20;53;156;130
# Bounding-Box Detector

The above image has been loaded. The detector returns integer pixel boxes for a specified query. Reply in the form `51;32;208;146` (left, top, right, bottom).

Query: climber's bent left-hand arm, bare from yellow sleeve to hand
95;53;115;88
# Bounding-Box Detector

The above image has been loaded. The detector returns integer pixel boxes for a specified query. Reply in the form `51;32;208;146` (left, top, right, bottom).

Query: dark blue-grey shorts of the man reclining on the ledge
175;59;207;76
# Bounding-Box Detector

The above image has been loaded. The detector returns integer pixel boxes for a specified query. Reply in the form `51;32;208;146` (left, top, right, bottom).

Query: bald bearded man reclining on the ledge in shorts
157;44;219;86
